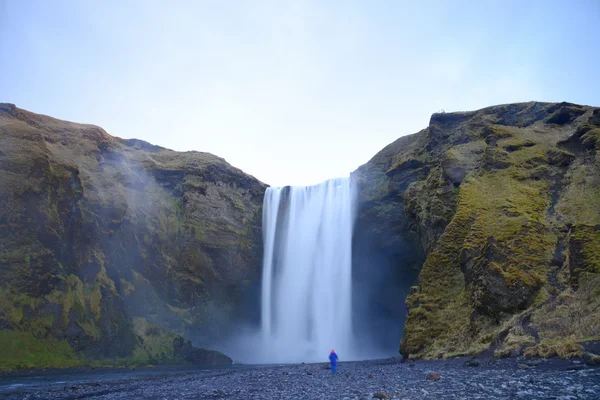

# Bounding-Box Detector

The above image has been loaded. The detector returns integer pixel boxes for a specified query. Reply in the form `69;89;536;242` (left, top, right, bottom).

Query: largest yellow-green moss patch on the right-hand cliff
403;131;558;358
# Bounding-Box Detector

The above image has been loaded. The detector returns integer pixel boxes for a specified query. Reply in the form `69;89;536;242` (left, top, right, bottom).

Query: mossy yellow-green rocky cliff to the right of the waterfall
353;103;600;358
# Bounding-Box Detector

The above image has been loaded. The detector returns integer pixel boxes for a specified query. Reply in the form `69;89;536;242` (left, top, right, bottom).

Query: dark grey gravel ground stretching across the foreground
0;359;600;400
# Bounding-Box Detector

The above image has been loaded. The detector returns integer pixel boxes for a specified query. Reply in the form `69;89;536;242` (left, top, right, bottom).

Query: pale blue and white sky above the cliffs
0;0;600;186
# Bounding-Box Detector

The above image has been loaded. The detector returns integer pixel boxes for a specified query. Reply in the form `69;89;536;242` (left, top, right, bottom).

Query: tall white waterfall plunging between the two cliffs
261;178;355;362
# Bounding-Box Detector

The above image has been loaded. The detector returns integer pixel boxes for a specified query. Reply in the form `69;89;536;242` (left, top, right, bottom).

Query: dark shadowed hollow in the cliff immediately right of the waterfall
352;200;425;354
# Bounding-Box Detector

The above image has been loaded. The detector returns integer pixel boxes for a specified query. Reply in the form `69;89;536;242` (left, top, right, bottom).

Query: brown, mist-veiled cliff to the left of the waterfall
0;104;265;367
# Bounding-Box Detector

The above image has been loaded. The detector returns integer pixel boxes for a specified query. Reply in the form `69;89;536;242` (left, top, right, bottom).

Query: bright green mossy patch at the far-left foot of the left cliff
0;329;84;371
